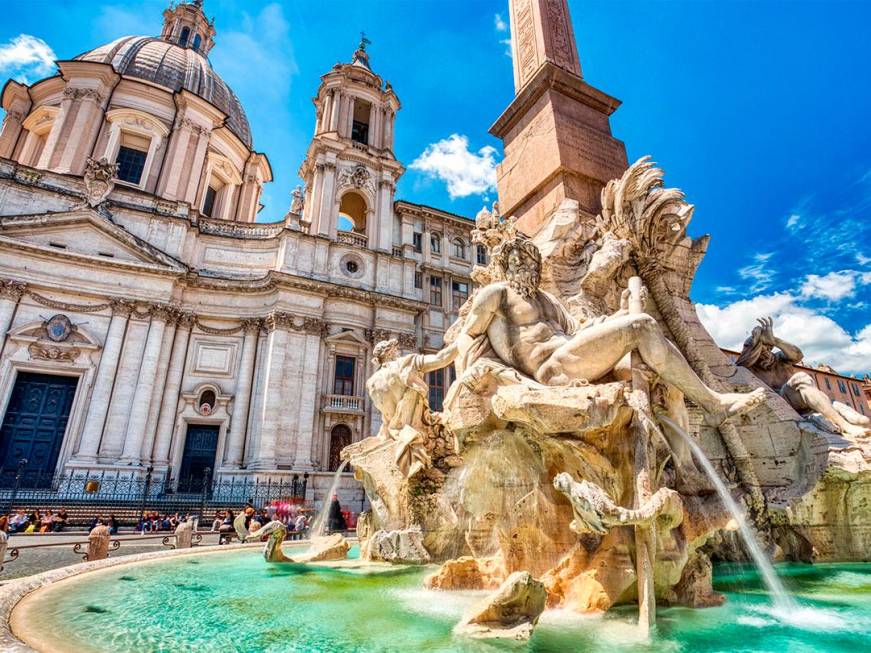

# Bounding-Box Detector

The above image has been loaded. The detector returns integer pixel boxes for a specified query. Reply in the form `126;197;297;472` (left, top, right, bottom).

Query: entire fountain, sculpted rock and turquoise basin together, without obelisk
0;159;871;653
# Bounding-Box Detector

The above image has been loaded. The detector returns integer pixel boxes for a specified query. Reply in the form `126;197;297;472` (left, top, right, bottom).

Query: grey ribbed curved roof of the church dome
76;36;251;148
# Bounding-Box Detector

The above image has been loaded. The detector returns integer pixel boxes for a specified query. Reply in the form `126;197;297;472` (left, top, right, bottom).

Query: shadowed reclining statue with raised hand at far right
736;317;871;437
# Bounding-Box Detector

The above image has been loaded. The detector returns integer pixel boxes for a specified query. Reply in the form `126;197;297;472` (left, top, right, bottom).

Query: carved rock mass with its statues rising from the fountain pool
343;159;856;628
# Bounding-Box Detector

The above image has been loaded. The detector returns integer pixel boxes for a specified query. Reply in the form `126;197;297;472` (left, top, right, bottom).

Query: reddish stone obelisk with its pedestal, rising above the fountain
490;0;628;235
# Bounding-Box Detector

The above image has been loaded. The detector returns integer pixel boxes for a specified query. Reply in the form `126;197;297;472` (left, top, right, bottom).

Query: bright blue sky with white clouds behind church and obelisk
0;0;871;372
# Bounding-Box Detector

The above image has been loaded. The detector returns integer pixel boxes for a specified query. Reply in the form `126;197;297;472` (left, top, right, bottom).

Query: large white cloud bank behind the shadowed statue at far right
696;292;871;373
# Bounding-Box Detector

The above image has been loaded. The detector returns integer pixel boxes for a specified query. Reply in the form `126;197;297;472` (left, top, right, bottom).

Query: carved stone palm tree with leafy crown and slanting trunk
596;156;764;516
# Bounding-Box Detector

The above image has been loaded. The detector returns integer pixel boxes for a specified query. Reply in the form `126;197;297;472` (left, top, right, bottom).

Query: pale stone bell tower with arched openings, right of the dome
299;34;405;252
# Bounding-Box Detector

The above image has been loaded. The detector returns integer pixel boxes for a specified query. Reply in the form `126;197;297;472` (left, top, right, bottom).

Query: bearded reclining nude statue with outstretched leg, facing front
414;236;765;425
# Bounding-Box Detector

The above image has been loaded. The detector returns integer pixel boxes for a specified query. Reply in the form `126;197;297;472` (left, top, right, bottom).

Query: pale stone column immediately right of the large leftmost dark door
73;299;133;462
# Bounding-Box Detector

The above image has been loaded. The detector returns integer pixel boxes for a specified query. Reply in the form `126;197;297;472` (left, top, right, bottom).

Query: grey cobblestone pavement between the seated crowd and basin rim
0;531;225;584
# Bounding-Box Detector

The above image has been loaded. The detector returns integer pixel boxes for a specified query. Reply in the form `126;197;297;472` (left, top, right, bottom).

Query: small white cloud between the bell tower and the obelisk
409;134;496;199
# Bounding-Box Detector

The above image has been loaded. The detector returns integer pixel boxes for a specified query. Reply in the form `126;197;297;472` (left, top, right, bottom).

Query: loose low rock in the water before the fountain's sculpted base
454;571;547;640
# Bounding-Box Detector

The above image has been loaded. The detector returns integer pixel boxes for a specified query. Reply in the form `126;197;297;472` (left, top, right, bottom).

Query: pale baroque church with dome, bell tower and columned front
0;1;486;502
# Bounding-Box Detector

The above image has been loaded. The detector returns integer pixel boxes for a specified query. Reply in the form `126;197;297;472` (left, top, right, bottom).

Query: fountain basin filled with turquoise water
0;545;871;653
